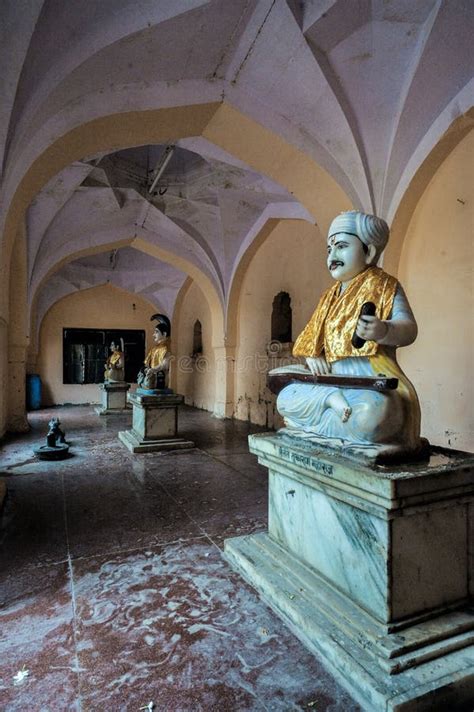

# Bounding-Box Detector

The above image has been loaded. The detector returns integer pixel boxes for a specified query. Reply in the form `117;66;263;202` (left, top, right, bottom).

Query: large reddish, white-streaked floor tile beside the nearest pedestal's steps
74;540;356;712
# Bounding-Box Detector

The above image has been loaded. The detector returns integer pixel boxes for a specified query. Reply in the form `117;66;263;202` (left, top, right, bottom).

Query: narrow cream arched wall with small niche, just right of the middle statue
173;282;215;411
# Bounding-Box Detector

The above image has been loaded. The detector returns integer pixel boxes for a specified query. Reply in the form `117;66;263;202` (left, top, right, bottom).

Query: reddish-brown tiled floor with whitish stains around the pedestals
0;406;359;712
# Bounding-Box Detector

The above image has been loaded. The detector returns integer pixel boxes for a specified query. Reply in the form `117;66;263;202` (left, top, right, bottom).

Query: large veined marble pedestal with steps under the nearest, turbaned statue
225;433;474;712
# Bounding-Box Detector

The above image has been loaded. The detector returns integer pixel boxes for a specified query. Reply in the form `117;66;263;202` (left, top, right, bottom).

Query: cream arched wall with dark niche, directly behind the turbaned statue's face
234;220;332;427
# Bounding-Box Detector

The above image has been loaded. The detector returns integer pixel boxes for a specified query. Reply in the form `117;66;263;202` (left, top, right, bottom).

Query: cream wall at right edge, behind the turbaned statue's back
398;133;474;451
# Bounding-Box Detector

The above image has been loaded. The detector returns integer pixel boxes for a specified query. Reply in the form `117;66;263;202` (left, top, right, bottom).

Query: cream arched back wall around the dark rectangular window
37;284;156;405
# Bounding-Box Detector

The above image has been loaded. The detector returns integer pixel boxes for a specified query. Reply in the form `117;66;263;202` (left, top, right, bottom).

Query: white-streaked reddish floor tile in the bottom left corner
0;563;78;710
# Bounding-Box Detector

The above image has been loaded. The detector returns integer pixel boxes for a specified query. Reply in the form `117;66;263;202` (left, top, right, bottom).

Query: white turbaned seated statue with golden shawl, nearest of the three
270;211;427;453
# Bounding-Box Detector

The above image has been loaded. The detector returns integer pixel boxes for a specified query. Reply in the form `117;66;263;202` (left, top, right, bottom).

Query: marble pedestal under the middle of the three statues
118;393;194;453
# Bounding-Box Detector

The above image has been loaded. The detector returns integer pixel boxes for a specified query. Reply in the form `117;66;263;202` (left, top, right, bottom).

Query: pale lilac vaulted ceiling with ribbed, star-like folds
0;0;474;328
